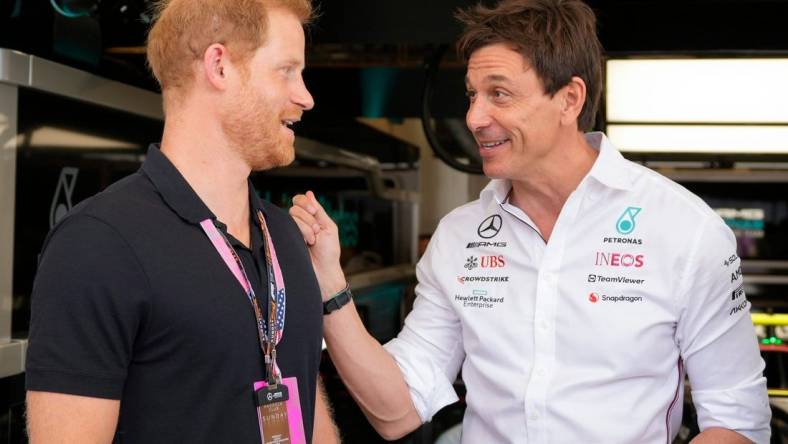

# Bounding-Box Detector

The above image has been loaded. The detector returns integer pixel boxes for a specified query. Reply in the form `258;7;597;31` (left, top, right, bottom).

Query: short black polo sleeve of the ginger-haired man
25;214;149;399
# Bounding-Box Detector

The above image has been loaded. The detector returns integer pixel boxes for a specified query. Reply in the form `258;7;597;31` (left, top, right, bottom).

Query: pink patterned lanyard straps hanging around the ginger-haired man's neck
200;210;287;384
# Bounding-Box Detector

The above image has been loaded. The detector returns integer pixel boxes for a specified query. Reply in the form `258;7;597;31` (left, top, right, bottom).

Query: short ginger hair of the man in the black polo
147;0;312;91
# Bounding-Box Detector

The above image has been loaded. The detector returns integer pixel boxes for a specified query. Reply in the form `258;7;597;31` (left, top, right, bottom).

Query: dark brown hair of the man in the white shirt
457;0;602;131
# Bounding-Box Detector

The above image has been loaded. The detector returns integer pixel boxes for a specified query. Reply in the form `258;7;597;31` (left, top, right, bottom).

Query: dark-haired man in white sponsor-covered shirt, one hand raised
291;0;770;444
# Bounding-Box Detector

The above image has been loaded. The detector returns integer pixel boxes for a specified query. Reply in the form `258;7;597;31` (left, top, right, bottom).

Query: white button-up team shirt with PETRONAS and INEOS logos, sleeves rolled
385;133;771;444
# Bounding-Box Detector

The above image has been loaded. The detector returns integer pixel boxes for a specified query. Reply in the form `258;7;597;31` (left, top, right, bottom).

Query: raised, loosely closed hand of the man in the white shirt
290;191;346;301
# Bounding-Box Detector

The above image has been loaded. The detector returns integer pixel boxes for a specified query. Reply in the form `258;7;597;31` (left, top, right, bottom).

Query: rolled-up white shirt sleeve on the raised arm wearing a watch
385;230;465;422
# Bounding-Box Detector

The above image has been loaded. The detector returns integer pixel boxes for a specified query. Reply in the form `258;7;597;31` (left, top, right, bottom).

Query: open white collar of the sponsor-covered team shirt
479;132;632;207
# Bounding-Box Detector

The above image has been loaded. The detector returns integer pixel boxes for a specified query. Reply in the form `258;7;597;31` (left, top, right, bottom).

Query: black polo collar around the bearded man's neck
142;144;265;224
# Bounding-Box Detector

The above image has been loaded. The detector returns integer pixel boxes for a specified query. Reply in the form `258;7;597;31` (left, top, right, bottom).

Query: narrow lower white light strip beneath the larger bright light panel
607;124;788;154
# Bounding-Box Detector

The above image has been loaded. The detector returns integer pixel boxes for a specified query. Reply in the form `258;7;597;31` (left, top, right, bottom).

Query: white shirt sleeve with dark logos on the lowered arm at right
676;215;771;443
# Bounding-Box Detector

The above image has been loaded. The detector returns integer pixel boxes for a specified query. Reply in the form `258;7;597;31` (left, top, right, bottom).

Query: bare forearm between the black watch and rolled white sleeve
323;302;421;439
